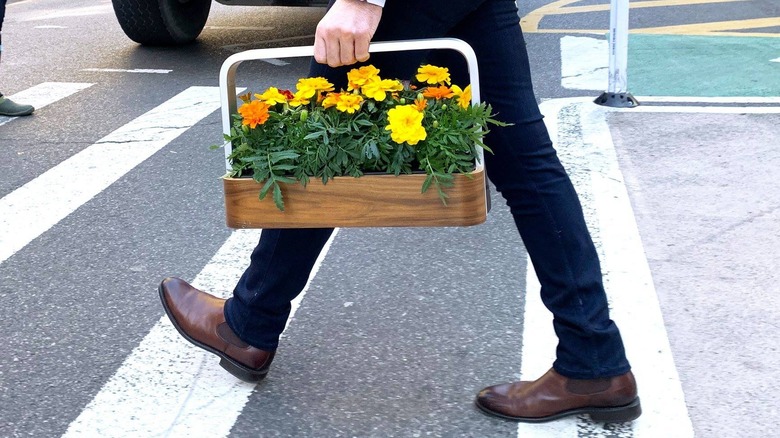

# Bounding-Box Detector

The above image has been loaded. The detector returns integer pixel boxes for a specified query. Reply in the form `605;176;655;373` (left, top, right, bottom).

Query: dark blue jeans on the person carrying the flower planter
225;0;630;378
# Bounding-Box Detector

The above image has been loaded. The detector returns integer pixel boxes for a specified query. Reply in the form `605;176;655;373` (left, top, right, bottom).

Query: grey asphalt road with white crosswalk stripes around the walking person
0;0;780;437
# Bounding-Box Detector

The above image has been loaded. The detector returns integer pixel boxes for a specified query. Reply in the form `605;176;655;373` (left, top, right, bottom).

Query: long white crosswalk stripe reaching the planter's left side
0;87;229;263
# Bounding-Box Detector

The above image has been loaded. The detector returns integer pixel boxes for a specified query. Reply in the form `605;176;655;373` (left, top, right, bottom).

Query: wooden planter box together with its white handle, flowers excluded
219;38;490;228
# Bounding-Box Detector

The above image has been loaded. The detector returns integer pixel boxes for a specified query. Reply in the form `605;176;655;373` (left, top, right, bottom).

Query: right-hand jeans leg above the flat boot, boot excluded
444;0;629;379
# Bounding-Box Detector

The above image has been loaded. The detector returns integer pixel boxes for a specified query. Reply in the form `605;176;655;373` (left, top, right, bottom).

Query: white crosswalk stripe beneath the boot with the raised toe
64;230;338;438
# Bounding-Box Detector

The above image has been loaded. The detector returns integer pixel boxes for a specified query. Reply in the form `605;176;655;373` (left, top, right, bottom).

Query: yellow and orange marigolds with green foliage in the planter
217;65;504;211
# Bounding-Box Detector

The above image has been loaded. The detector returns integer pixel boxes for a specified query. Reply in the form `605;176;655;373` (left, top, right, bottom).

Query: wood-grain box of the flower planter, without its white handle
223;169;488;228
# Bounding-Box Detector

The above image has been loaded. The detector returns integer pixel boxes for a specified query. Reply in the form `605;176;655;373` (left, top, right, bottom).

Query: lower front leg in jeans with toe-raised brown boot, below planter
159;229;333;382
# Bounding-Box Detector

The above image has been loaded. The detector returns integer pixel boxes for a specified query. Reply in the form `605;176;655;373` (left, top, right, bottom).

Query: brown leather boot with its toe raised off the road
159;278;276;383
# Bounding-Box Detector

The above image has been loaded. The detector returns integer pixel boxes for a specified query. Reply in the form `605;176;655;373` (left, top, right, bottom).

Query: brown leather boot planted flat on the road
475;369;642;423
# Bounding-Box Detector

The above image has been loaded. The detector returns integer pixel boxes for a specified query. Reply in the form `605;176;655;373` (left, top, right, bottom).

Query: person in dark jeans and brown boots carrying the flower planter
159;0;641;422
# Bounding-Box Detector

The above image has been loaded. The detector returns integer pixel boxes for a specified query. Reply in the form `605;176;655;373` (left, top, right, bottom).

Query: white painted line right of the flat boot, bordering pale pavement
578;102;693;438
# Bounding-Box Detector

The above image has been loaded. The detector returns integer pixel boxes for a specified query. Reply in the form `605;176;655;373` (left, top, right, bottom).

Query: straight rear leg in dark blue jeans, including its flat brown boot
438;0;641;422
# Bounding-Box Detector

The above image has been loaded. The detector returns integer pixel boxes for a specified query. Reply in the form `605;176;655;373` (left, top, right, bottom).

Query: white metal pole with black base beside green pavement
595;0;639;108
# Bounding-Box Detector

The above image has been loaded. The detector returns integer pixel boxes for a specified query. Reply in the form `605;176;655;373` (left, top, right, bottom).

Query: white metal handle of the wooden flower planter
219;38;484;171
